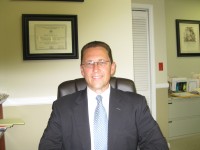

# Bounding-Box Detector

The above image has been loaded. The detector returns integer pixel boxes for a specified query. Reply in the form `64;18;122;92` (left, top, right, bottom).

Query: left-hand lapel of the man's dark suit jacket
74;90;91;150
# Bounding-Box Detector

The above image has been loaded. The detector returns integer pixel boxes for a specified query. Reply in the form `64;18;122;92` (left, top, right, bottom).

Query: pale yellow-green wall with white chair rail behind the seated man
0;0;168;150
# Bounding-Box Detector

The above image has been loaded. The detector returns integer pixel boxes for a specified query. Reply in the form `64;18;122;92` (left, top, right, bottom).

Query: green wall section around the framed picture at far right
165;0;200;77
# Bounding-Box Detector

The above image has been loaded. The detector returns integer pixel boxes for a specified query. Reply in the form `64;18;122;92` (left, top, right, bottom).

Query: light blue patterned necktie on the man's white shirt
94;95;108;150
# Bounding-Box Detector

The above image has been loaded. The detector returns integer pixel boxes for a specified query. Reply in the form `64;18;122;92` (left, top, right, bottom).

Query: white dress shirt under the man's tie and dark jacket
87;85;110;150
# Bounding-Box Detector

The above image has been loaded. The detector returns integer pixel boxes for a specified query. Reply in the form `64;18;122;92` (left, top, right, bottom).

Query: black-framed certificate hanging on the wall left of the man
22;14;78;60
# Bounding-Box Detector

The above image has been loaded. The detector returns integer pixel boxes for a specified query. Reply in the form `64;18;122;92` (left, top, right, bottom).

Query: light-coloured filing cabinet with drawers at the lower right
168;96;200;139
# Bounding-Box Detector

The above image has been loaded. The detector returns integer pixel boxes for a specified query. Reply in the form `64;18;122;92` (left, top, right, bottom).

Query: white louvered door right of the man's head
132;4;156;119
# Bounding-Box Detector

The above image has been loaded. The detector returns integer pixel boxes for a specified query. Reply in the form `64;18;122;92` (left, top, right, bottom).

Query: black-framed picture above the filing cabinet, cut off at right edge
176;19;200;57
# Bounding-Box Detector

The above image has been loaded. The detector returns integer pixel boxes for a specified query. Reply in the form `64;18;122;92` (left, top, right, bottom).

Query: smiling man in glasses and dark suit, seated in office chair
39;41;168;150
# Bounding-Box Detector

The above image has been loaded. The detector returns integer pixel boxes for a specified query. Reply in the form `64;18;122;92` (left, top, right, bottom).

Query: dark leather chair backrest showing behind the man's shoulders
57;77;136;98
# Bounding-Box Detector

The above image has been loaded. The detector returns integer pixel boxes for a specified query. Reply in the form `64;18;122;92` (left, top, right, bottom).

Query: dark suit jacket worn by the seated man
39;88;168;150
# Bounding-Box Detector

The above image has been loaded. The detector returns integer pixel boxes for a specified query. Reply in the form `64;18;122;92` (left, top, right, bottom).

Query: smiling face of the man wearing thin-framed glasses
81;47;116;94
